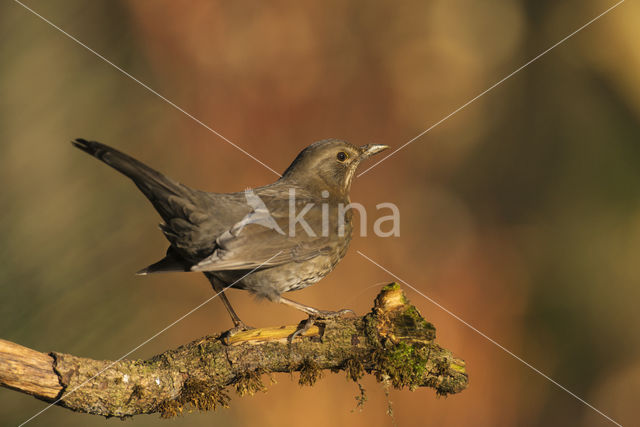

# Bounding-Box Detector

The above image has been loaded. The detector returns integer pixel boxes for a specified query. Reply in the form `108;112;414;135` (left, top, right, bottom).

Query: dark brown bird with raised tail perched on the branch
72;138;388;336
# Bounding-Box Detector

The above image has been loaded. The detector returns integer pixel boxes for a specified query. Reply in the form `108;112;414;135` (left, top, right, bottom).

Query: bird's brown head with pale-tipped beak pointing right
282;139;389;195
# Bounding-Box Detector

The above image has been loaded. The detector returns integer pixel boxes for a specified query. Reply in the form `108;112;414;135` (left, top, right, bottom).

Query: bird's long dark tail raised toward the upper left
72;139;192;221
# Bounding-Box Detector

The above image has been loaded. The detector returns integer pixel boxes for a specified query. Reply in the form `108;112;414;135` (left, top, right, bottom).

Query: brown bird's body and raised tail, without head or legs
74;140;351;290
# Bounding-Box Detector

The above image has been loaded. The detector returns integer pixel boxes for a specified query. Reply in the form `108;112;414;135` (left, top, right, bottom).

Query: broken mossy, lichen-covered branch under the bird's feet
0;284;468;417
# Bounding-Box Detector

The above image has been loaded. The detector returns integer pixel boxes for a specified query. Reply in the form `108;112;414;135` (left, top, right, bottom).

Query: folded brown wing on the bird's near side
191;197;332;271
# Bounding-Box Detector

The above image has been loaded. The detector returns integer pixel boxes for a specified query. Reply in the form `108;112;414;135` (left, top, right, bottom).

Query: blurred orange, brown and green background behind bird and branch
0;0;640;426
